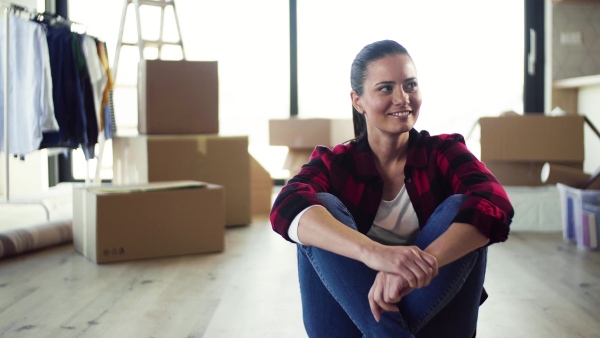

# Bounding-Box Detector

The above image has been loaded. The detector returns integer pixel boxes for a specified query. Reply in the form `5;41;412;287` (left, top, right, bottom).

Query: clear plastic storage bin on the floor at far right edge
556;183;600;249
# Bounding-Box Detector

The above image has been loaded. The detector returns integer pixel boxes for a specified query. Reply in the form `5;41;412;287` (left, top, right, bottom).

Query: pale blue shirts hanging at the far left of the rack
0;13;60;156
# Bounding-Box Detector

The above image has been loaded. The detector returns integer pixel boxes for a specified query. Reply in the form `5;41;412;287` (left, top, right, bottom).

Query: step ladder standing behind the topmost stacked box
112;0;186;80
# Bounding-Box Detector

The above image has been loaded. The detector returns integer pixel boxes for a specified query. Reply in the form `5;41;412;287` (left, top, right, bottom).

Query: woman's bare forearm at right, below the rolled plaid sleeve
424;223;489;267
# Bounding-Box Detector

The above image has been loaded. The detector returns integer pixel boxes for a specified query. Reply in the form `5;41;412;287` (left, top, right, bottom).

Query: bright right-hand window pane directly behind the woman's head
298;0;524;154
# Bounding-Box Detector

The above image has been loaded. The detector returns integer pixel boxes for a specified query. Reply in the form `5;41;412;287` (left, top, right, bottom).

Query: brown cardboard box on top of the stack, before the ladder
138;60;219;134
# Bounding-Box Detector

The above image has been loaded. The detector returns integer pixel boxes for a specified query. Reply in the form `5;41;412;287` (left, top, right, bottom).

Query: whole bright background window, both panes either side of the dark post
69;0;524;179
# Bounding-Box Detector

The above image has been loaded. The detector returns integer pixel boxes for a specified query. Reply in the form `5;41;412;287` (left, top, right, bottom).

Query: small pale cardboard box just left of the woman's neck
269;118;354;149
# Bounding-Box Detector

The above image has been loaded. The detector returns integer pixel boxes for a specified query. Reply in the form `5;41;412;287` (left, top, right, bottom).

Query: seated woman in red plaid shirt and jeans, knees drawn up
271;40;513;338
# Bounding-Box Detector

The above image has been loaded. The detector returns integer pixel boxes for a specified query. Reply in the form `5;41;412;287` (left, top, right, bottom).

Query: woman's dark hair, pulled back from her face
350;40;410;140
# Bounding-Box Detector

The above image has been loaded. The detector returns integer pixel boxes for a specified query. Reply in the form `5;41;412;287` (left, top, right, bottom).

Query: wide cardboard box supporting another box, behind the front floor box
112;134;252;225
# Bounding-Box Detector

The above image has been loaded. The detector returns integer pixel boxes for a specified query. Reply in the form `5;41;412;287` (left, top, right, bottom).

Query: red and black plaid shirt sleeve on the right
434;134;514;244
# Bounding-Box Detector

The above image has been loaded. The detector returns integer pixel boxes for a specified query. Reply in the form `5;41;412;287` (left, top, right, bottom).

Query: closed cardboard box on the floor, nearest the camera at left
73;182;225;263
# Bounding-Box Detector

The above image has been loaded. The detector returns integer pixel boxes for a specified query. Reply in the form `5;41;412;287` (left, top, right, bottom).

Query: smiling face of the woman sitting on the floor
352;55;421;136
